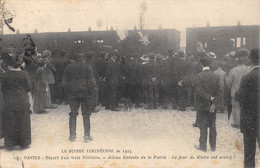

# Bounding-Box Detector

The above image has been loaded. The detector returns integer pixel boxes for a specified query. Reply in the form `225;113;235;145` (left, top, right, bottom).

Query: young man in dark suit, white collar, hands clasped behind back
194;53;222;152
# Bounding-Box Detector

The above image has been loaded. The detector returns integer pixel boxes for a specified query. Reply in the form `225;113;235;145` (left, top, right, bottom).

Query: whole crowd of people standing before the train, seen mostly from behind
0;35;259;168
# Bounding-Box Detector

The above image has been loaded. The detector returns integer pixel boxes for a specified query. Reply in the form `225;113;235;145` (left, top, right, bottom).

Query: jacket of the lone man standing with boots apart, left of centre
62;61;95;98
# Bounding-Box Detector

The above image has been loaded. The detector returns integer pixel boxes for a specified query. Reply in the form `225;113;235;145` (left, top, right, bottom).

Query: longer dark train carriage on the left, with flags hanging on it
2;29;180;57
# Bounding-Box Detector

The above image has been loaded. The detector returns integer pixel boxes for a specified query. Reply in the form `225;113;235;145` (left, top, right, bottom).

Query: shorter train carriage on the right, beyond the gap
186;24;260;59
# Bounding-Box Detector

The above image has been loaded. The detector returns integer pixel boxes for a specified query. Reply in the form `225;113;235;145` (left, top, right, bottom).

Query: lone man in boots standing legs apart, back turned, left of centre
62;52;95;142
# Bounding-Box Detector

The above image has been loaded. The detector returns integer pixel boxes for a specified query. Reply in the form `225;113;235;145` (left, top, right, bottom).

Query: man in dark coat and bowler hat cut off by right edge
236;48;260;168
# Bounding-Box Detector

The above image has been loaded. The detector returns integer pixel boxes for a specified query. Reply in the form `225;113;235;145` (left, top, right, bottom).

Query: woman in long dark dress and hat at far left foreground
1;50;32;149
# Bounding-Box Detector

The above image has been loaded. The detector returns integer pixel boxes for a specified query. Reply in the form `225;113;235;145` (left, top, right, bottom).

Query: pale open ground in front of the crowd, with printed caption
0;105;260;168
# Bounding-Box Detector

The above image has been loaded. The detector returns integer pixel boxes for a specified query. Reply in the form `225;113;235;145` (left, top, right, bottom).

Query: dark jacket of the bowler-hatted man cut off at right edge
236;67;260;132
